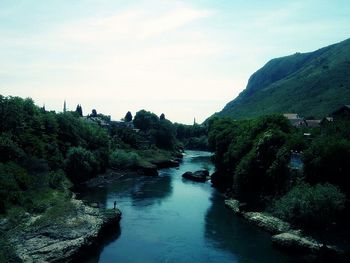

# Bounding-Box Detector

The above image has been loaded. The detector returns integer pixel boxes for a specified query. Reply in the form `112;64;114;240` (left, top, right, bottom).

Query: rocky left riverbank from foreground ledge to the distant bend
0;150;182;262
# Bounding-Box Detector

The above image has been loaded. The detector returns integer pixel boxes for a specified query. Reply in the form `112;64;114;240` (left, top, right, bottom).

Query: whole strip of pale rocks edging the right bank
225;199;345;262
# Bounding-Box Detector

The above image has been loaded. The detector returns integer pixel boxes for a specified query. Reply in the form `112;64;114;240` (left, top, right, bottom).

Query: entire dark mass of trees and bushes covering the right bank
209;115;350;227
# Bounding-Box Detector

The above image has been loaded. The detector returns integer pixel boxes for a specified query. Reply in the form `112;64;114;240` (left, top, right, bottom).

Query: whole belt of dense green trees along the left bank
0;96;205;216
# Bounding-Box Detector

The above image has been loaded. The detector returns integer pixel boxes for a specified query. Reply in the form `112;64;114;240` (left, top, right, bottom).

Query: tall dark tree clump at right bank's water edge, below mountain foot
209;115;292;200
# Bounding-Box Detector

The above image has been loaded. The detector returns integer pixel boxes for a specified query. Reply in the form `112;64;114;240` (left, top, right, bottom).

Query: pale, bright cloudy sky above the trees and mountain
0;0;350;124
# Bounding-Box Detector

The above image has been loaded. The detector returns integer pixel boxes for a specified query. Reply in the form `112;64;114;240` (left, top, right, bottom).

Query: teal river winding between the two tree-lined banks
78;151;300;263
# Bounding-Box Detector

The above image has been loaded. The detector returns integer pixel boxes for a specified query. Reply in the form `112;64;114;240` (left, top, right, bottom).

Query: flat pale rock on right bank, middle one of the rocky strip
243;212;291;234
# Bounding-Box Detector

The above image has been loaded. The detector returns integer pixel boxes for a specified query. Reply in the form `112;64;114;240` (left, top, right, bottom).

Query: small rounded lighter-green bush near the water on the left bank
109;150;141;168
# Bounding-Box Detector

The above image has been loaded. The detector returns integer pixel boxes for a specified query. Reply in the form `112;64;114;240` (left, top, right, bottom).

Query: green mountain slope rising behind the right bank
217;39;350;119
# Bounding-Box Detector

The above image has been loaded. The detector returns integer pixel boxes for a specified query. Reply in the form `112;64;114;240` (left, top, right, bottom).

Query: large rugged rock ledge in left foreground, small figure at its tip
10;200;121;262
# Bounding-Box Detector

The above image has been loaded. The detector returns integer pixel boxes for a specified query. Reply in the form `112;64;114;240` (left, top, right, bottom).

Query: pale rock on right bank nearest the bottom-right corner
272;232;322;253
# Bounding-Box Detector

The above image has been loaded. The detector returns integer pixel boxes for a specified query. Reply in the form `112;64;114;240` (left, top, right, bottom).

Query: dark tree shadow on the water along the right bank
204;192;311;263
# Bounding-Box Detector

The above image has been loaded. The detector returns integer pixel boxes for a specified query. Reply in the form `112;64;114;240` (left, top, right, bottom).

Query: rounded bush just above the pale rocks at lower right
272;183;346;228
